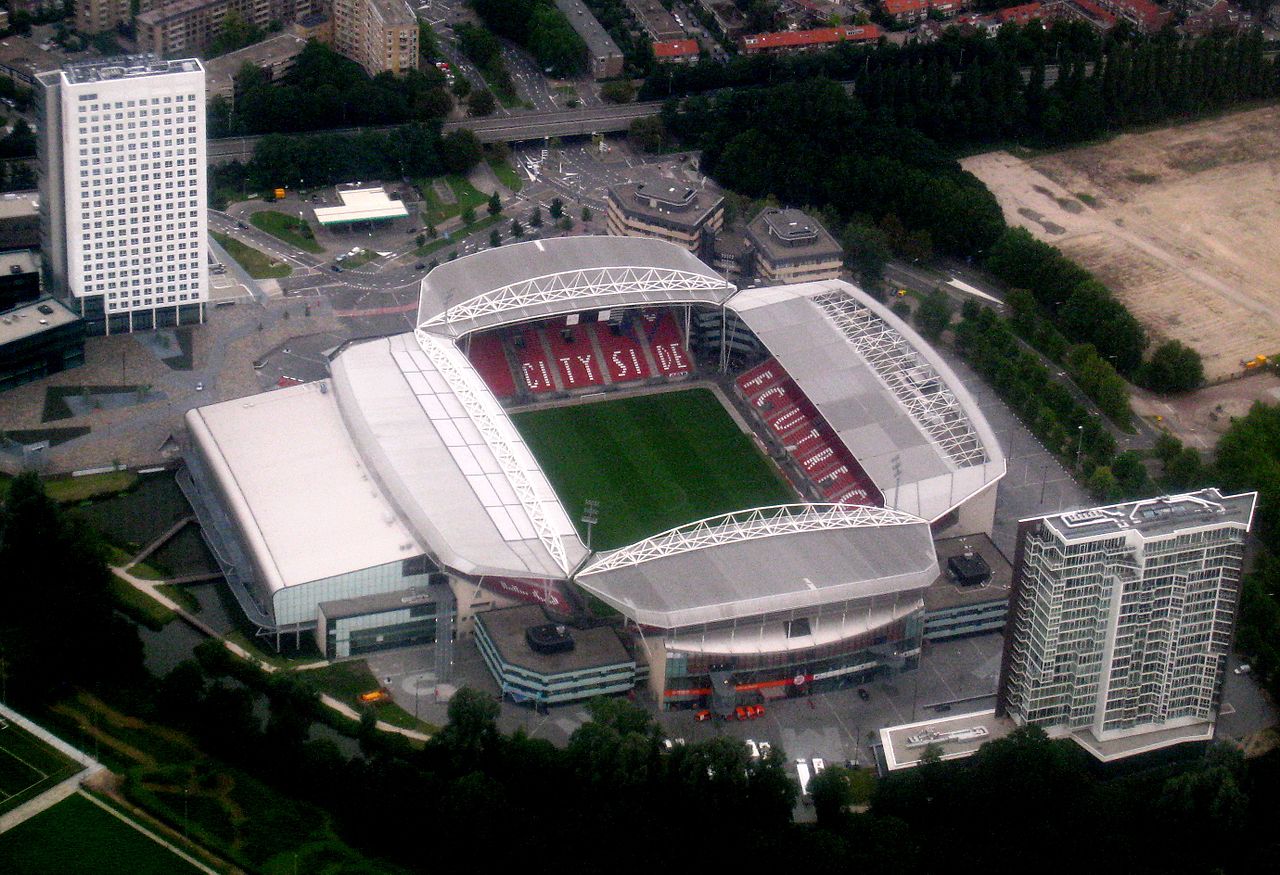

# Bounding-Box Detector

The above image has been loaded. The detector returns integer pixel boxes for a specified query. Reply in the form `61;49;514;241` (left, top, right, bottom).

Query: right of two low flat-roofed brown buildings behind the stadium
746;207;845;284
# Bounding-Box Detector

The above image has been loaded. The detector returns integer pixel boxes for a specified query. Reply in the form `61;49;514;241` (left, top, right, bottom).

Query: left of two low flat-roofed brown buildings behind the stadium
605;178;724;257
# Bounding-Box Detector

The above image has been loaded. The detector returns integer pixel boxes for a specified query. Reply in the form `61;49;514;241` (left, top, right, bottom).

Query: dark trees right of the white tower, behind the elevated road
207;41;453;137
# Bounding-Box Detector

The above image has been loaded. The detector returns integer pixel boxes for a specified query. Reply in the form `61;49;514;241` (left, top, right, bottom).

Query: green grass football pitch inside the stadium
512;389;799;550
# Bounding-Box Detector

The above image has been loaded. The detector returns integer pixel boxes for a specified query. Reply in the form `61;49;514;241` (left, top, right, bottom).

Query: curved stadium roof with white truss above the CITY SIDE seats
417;237;733;336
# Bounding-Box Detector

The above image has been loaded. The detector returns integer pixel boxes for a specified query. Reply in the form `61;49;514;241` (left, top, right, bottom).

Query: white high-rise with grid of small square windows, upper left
37;55;209;334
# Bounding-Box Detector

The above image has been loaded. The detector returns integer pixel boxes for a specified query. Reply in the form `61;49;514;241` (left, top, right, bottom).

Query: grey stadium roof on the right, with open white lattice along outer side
728;280;1005;521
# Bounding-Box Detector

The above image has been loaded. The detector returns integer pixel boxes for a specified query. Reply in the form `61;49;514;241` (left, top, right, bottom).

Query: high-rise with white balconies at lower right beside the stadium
998;489;1257;760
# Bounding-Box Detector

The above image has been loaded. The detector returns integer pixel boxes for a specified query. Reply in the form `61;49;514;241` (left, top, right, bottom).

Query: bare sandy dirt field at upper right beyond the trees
963;106;1280;382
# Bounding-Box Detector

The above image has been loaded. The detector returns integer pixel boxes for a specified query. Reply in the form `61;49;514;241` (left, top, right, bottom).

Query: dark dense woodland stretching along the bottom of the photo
0;475;1280;875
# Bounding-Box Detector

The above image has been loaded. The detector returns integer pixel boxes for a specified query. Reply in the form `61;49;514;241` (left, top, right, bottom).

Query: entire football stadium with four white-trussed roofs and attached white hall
179;237;1005;710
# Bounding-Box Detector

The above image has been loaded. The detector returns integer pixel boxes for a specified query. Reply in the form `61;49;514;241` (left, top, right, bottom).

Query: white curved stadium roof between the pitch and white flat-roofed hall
332;333;586;578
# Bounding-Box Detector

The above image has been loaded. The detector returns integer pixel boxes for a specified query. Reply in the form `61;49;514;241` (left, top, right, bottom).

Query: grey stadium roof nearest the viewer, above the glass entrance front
576;504;938;629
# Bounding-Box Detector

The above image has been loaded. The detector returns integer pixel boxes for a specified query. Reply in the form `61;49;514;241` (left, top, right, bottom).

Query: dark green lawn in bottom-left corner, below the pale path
0;796;200;875
